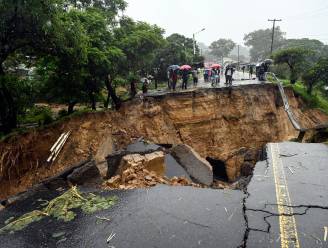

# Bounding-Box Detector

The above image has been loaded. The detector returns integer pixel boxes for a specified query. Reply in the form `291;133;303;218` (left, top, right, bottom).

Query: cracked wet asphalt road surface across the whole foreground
0;142;328;248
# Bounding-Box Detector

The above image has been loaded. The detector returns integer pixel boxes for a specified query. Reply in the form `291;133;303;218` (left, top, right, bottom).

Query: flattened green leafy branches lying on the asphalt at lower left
0;187;118;234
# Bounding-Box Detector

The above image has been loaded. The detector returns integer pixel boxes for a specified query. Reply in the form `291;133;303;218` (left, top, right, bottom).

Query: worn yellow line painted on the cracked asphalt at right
270;144;300;248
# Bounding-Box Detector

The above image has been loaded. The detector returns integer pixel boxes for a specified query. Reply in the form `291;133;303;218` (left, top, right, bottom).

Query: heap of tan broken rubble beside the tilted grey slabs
103;152;202;190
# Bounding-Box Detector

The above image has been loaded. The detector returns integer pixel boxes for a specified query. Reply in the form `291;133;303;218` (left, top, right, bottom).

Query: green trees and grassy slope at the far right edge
272;39;328;113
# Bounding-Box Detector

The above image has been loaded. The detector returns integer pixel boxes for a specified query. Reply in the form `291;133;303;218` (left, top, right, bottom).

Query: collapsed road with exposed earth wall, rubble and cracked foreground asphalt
0;80;328;248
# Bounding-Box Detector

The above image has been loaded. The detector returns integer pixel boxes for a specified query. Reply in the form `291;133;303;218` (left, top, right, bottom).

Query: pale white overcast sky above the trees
126;0;328;45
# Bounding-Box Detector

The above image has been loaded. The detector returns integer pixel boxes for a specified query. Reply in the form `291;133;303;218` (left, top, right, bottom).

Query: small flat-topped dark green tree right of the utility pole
273;48;313;84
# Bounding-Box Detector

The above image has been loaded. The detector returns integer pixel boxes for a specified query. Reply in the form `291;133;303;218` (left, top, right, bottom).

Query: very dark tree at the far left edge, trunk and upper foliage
0;0;64;133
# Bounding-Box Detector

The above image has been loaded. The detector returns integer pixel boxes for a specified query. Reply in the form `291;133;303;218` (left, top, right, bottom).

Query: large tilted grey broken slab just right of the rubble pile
171;145;213;186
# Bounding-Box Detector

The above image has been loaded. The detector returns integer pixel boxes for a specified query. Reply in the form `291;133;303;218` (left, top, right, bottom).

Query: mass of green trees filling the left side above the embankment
0;0;202;134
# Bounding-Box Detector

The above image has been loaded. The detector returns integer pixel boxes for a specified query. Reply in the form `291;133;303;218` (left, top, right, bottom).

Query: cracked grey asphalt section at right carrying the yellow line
245;142;328;247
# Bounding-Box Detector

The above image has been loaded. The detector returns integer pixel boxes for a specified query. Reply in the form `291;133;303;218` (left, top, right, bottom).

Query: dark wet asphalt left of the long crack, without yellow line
0;186;246;248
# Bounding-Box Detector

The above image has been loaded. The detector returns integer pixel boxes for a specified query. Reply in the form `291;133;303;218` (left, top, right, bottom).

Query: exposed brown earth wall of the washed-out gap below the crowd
0;84;328;198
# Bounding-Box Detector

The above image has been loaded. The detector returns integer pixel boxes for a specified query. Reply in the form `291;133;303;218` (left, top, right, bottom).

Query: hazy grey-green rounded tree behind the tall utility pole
244;26;285;62
